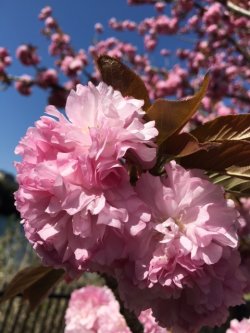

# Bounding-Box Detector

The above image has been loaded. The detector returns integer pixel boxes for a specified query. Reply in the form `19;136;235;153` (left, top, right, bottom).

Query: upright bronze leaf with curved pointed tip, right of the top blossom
146;74;209;144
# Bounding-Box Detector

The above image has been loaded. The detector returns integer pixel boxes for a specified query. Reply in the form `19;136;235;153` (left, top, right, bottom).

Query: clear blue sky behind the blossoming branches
0;0;184;173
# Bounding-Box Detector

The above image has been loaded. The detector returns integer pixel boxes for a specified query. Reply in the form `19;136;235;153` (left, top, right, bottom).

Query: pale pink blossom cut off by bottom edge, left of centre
64;286;131;333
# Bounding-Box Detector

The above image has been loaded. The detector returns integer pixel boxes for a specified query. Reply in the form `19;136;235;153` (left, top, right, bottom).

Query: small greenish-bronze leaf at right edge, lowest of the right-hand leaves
209;173;250;197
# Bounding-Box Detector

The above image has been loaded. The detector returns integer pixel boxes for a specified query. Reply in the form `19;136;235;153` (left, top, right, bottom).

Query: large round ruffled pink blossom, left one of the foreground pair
15;83;158;276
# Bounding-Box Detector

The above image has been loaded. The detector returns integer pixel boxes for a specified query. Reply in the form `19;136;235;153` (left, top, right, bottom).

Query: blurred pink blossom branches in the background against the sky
0;0;250;122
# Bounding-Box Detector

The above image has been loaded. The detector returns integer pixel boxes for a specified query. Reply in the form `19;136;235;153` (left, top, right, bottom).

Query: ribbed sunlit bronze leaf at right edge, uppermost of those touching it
191;114;250;142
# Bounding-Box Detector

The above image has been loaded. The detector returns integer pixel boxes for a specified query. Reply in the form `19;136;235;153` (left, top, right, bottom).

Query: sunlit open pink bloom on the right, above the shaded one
136;162;237;278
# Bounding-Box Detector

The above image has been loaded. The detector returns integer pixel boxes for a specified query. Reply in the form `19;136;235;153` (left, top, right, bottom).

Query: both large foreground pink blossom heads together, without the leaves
15;82;245;333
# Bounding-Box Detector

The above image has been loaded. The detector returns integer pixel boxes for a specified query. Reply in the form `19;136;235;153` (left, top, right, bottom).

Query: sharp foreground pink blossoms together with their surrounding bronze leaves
2;55;250;333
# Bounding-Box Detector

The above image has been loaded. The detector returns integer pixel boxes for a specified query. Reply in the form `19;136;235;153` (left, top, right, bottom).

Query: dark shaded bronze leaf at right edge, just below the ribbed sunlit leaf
180;140;250;179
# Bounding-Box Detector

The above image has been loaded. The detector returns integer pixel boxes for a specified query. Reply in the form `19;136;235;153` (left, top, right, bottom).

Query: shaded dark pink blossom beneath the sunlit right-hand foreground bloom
116;248;245;333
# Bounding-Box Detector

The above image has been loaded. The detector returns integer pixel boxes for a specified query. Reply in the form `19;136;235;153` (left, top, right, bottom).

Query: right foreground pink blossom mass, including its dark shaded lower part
117;162;245;332
